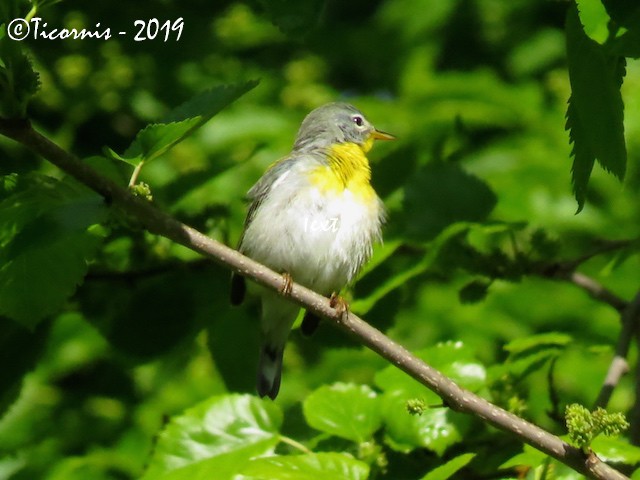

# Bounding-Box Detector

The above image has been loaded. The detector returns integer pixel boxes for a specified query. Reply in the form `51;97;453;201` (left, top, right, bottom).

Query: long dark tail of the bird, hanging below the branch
256;293;300;399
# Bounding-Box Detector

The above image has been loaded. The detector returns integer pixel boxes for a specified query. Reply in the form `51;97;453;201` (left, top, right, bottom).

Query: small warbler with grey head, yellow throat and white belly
231;103;395;399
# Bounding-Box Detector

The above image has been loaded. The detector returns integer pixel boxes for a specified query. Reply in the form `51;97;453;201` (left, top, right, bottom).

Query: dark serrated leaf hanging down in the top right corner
566;5;627;210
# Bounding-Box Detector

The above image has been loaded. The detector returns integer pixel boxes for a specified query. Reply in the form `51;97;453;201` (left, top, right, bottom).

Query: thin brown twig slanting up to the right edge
594;292;640;408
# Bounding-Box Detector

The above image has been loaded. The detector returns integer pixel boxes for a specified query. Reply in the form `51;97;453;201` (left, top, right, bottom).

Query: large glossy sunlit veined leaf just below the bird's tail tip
143;395;282;480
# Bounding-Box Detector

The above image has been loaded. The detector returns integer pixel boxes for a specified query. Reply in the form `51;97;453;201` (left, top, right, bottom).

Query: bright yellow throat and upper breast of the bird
311;142;375;202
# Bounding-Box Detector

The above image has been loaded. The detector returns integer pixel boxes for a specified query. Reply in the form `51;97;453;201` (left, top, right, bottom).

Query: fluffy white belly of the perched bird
243;188;381;294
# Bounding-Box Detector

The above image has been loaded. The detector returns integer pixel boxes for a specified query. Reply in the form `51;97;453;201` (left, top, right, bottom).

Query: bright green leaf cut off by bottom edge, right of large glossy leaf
242;452;369;480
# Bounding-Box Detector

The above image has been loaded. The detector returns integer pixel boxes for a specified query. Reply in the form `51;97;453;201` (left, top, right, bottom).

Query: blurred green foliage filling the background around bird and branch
0;0;640;480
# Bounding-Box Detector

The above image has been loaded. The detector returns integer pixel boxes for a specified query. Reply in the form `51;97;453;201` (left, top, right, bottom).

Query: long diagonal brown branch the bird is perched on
0;119;627;479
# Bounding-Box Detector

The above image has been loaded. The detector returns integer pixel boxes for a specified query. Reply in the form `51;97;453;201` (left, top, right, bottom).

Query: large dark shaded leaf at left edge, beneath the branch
0;177;107;328
